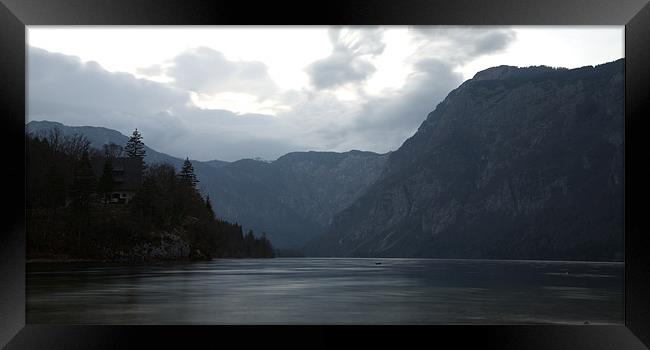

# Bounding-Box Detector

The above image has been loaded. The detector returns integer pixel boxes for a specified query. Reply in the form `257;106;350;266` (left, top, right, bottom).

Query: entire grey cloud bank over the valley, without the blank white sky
28;27;514;160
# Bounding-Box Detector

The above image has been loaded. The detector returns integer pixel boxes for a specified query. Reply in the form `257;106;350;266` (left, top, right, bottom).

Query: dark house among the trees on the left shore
91;158;143;204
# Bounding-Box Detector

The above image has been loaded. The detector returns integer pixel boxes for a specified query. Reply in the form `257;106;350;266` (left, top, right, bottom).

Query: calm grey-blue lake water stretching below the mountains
26;258;624;324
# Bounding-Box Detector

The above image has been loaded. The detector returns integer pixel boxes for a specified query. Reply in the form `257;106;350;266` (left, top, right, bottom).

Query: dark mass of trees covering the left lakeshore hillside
25;131;273;259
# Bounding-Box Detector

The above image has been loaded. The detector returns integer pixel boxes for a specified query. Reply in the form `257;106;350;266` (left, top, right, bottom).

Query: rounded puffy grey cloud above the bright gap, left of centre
165;47;278;98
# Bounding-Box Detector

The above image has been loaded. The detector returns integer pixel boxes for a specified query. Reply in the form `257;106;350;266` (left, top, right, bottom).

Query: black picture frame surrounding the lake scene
0;0;650;349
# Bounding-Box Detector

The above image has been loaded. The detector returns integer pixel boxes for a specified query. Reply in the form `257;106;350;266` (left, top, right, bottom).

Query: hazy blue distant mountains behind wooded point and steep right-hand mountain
26;121;388;249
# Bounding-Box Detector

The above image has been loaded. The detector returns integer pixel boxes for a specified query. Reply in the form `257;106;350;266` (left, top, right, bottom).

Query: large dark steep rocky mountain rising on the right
306;59;624;260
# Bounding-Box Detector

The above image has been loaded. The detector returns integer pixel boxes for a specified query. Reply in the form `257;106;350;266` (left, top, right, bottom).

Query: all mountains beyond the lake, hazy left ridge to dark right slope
26;59;624;260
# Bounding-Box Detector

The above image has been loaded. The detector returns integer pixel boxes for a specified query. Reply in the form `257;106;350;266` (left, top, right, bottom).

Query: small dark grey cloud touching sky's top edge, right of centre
306;28;386;89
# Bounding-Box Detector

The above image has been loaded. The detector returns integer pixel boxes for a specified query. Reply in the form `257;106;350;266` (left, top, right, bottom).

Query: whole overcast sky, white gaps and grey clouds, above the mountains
27;26;624;160
